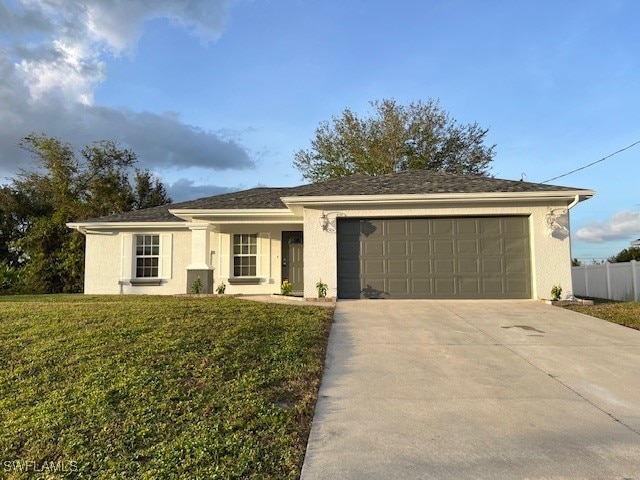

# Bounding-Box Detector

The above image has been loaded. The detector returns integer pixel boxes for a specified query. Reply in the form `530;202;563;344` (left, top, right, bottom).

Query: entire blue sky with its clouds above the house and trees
0;0;640;261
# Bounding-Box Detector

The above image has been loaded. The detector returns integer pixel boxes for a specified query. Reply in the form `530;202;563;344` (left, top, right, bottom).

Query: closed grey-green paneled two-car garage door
337;217;531;298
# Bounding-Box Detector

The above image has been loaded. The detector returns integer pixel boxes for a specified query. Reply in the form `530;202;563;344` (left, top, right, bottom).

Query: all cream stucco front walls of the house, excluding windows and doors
85;204;572;298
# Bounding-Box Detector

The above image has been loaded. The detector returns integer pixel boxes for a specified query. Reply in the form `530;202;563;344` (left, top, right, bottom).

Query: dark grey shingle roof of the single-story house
80;170;583;222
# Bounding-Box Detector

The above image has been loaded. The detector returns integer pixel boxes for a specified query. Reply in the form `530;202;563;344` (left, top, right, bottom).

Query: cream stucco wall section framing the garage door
304;204;572;298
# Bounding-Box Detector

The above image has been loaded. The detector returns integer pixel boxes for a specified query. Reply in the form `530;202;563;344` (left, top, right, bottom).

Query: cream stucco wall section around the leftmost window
84;229;191;295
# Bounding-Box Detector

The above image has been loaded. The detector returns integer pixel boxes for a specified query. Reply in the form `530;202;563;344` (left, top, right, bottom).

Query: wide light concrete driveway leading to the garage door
301;300;640;480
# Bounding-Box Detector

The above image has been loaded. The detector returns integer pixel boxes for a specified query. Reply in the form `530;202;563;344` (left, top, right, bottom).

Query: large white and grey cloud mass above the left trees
0;0;255;175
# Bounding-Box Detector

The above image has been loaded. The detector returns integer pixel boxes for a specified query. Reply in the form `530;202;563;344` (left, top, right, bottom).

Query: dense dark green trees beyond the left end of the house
0;135;171;293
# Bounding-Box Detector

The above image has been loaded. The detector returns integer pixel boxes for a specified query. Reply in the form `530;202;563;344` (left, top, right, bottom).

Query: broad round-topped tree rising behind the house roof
294;99;495;182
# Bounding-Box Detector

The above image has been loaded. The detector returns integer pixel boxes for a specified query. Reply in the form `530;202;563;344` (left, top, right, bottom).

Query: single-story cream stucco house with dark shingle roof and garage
69;170;594;299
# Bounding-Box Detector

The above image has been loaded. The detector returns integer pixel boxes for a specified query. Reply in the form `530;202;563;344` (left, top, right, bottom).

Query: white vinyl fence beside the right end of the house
571;260;640;302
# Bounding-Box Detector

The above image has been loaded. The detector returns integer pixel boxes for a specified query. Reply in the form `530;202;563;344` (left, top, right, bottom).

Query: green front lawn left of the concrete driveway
0;295;332;479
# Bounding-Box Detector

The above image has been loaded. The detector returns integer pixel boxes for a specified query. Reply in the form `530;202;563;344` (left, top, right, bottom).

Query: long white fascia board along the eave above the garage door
282;190;595;207
